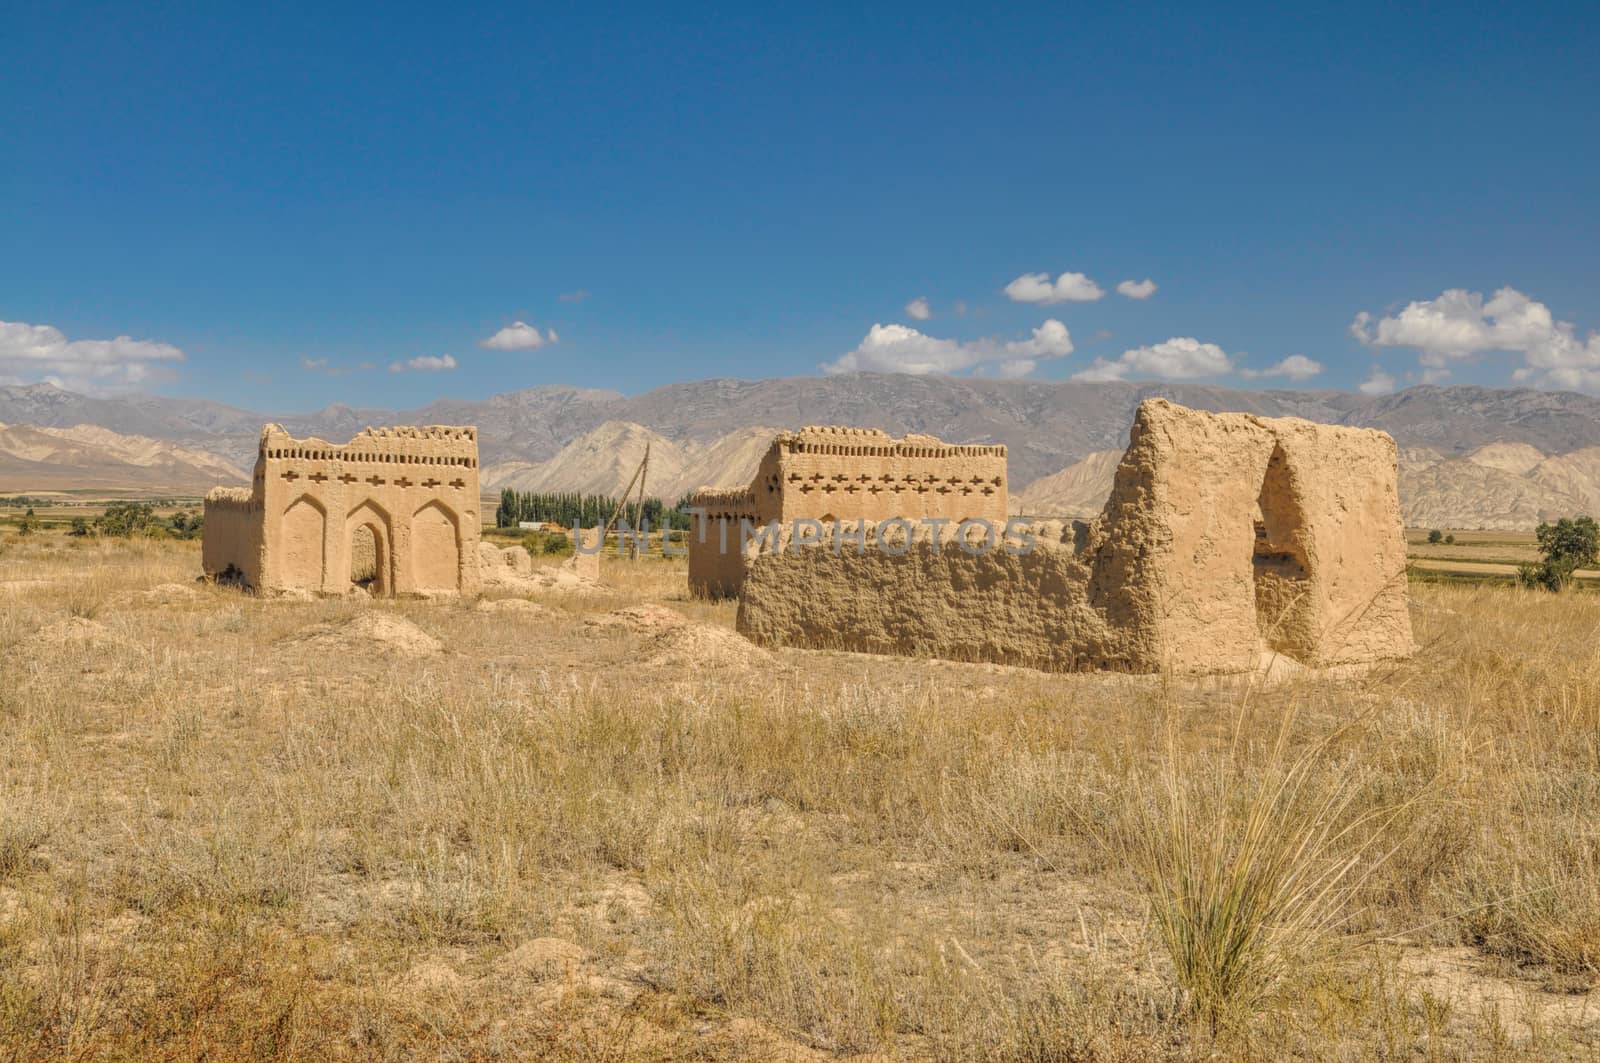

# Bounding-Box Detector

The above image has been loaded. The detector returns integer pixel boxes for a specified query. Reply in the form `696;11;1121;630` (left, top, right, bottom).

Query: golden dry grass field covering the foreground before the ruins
0;530;1600;1060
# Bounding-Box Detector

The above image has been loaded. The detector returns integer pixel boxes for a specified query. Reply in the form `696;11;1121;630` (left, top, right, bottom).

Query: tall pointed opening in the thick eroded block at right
1251;447;1317;658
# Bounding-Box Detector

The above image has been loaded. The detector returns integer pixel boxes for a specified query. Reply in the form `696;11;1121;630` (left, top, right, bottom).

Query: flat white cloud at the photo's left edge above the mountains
0;322;184;394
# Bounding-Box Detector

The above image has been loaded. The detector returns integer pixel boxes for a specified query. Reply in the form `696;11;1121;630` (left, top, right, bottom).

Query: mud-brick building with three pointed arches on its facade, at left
202;424;480;594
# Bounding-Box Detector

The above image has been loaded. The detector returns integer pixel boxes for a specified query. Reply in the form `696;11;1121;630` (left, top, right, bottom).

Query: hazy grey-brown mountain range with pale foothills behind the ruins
0;373;1600;527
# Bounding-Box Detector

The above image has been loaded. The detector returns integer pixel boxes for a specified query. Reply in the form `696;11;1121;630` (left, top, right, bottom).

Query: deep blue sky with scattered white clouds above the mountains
0;3;1600;410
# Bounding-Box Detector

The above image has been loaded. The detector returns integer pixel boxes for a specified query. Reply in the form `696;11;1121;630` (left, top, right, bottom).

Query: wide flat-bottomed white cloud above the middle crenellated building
821;319;1072;376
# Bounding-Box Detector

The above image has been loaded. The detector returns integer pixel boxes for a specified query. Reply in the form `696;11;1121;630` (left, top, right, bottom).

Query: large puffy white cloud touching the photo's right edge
1350;288;1600;391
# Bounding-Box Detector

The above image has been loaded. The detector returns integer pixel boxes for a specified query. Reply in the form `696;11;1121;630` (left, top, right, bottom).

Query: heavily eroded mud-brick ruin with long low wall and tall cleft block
732;399;1413;672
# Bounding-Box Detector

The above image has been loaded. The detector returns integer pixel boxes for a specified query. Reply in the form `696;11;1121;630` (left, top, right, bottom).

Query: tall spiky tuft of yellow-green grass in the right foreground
1120;712;1400;1036
